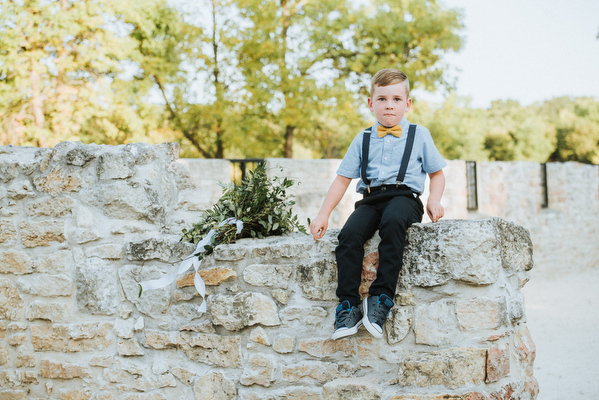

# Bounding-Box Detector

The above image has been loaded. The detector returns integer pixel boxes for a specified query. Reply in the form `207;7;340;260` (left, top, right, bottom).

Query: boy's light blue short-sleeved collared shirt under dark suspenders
337;118;447;193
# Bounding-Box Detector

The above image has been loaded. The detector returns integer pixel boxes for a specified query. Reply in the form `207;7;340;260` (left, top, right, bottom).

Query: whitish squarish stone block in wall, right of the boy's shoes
414;299;459;346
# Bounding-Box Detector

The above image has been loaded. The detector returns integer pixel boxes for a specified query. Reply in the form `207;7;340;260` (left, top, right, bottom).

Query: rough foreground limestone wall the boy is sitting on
0;142;538;400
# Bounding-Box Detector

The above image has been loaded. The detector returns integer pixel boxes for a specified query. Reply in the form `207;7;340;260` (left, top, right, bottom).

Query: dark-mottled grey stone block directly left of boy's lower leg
296;259;337;300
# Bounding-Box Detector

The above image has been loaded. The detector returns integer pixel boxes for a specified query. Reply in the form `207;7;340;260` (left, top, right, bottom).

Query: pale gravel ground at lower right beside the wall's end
522;268;599;400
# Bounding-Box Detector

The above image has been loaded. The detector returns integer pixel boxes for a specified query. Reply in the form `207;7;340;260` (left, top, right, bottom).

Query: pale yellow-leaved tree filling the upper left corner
0;0;177;146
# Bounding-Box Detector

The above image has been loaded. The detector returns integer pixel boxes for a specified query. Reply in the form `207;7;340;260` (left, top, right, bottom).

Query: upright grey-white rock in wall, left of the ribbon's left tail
76;257;119;315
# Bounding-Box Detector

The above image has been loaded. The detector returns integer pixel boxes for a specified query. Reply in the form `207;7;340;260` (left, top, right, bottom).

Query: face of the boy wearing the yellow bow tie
368;82;412;127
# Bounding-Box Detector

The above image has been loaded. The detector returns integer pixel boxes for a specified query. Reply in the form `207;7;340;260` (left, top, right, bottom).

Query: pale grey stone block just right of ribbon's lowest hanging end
208;293;281;331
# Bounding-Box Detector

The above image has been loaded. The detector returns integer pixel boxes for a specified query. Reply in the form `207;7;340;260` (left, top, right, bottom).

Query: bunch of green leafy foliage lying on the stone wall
182;164;307;247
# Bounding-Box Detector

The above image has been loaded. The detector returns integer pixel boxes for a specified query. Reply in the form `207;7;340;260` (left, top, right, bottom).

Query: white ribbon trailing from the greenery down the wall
139;218;243;313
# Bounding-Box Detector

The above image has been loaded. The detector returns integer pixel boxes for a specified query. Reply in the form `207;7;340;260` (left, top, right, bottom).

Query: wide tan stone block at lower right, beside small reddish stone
398;348;487;389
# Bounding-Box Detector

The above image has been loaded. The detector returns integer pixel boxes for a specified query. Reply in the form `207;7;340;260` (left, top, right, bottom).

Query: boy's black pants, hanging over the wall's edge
335;190;424;306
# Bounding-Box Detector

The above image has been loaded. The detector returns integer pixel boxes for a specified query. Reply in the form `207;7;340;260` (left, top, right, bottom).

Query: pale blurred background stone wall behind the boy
188;159;599;276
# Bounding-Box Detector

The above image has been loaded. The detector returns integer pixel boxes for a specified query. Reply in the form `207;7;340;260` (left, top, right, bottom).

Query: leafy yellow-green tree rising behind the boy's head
232;0;461;157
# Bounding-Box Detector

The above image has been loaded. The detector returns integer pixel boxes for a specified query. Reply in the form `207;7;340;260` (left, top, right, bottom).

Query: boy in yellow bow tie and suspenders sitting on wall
310;69;447;339
